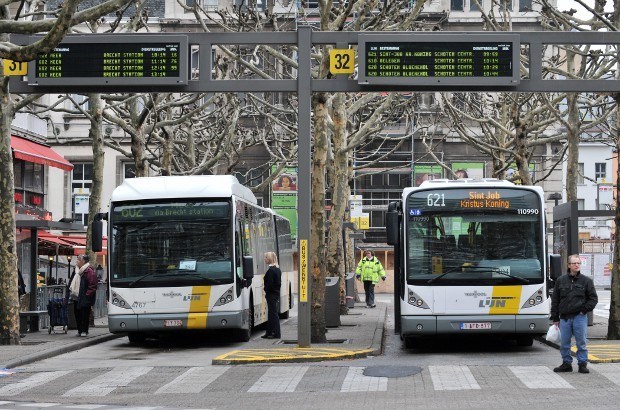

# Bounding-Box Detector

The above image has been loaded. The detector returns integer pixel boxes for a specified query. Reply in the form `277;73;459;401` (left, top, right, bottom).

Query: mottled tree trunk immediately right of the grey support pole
308;93;328;343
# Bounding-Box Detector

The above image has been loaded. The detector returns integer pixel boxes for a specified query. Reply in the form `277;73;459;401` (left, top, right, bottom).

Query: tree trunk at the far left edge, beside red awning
0;74;20;345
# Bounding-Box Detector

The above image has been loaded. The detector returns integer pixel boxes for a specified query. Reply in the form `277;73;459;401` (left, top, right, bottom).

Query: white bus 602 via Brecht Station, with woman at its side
93;176;293;343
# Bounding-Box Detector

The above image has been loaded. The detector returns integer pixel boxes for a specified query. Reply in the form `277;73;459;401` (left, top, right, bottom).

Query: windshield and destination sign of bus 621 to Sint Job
406;188;544;286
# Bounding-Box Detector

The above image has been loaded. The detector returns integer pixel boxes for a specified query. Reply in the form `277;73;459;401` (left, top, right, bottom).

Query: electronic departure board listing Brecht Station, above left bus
28;34;187;86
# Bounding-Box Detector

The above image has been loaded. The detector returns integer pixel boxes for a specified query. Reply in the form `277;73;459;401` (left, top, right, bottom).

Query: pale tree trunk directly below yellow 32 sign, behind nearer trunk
325;93;349;314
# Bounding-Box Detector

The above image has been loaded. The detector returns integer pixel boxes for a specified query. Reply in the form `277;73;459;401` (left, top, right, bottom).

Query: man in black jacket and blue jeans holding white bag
551;255;598;373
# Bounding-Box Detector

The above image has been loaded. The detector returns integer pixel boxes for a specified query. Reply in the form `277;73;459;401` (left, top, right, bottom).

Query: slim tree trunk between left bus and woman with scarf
86;94;105;262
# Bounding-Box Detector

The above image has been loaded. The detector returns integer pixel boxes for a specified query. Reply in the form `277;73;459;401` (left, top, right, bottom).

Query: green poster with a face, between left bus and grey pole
271;166;297;239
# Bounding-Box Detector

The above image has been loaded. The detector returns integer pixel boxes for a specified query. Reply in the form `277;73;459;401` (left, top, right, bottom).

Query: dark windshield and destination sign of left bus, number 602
108;201;233;287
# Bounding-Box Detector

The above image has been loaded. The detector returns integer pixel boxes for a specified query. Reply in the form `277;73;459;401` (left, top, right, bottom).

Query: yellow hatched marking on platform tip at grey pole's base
212;347;372;364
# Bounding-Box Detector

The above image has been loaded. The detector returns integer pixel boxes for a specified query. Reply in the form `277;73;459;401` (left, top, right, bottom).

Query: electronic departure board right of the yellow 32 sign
358;33;520;86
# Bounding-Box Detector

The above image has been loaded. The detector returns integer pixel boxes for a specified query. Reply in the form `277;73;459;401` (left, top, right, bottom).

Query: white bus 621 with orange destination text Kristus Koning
386;179;550;347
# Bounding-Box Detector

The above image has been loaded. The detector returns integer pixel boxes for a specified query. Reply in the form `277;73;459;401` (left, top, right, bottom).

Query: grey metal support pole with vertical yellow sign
297;26;312;347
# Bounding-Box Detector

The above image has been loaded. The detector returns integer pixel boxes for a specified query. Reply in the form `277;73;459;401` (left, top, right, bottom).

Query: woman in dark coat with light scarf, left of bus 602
70;255;97;337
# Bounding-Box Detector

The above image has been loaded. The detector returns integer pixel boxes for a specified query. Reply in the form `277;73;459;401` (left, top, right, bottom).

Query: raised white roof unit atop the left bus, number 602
110;175;256;204
